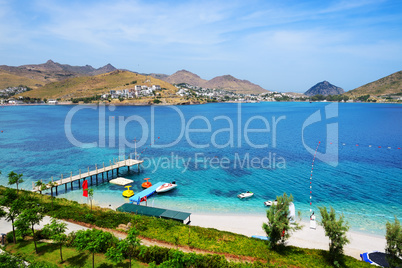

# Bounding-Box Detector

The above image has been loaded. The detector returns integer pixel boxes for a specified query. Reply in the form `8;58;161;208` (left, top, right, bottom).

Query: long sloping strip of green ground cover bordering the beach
0;187;370;267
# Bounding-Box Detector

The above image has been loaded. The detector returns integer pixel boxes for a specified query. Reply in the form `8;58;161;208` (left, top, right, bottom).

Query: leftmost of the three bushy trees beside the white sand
262;193;301;249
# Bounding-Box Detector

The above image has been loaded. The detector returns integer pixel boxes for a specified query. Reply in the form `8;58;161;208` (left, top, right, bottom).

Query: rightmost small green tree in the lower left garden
106;228;140;268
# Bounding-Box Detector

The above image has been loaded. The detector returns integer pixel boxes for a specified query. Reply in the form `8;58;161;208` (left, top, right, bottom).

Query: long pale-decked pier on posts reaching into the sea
32;159;144;195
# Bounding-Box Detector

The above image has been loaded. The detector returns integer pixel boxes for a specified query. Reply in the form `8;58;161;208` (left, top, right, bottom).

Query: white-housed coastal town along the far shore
0;83;402;105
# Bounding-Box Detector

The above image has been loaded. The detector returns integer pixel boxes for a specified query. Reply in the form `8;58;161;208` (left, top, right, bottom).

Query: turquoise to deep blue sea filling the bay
0;102;402;235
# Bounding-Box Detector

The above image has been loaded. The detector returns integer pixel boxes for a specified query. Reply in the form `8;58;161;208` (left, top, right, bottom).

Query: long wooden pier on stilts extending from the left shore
32;159;144;196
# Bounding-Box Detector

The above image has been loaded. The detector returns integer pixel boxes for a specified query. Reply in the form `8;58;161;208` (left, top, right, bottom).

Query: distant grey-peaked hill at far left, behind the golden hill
0;60;116;84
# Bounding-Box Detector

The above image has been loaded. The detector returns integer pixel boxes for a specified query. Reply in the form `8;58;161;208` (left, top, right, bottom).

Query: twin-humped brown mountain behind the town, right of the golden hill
154;70;268;94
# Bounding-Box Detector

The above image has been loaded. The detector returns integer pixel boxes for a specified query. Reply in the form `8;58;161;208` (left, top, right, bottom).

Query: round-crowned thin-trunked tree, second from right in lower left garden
74;229;117;267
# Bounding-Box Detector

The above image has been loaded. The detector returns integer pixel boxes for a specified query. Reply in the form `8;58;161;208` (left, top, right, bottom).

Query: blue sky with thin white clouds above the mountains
0;0;402;92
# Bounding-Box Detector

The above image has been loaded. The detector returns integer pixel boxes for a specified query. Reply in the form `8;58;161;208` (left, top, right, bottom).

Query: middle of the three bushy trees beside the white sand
319;207;349;261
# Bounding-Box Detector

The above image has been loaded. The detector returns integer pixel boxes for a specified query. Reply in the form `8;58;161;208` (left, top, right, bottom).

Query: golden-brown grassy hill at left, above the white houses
21;70;176;100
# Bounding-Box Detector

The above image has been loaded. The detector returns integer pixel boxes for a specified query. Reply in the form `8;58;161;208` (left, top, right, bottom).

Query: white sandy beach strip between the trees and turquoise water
191;214;386;260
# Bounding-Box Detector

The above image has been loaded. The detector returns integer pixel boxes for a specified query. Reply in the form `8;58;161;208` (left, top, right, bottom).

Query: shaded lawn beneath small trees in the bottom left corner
6;240;148;268
